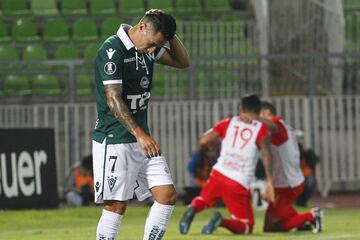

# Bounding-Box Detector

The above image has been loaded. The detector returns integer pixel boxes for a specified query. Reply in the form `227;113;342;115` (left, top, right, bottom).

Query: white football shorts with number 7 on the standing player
93;139;173;203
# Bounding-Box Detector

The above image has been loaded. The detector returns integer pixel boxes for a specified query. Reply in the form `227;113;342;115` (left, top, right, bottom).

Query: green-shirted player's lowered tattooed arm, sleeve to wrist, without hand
106;85;141;135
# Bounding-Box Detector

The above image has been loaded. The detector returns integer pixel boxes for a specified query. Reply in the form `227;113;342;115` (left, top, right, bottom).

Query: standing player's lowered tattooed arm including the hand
105;84;161;157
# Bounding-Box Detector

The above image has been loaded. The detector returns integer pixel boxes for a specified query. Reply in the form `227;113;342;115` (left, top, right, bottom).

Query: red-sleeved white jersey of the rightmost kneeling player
270;117;304;188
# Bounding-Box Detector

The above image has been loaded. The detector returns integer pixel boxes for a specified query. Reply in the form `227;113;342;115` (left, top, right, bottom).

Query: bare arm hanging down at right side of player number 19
259;137;275;202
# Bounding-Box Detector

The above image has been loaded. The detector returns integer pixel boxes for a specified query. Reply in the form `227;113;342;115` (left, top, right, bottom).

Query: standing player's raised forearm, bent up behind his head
169;35;190;68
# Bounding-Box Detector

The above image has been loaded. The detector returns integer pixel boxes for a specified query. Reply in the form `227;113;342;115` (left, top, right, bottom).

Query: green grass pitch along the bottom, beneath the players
0;206;360;240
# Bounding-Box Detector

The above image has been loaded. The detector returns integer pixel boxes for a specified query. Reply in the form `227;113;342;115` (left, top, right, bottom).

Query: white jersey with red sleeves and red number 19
213;117;268;189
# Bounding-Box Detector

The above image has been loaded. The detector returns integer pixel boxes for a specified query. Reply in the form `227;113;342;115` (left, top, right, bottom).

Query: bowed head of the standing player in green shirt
132;9;176;53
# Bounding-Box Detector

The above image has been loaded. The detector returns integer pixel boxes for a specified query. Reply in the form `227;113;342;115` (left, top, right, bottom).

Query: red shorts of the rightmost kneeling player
266;183;304;220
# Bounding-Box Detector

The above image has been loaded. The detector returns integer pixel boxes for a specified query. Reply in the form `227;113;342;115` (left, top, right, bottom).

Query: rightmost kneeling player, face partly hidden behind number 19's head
258;102;322;233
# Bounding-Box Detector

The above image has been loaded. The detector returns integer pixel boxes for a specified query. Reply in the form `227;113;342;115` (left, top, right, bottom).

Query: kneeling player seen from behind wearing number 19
180;95;274;234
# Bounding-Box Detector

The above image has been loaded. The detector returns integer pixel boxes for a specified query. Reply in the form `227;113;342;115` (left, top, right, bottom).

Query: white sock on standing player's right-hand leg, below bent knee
143;201;175;240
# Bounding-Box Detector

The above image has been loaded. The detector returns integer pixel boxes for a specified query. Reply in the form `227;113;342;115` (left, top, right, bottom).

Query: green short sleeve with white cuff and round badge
95;47;124;85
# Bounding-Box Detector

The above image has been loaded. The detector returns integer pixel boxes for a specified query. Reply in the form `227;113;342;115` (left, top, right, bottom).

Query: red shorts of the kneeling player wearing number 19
200;170;255;225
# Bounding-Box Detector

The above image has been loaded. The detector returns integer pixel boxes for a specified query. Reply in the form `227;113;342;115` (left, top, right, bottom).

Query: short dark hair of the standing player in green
141;9;176;40
